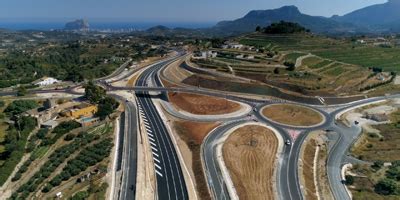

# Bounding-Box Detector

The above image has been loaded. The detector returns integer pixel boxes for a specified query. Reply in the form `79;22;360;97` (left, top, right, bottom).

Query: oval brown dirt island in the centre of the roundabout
262;104;323;126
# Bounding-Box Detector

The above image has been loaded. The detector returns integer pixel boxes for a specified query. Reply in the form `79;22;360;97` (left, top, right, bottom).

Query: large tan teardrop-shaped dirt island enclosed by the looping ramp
222;125;278;200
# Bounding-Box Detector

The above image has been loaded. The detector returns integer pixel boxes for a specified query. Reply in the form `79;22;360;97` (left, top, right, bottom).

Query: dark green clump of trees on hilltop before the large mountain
256;21;310;34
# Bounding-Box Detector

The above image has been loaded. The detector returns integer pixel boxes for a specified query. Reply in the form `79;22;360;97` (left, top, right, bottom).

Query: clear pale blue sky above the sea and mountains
0;0;386;22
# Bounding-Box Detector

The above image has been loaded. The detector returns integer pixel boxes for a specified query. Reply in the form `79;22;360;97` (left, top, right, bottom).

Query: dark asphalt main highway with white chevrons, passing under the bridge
136;60;189;199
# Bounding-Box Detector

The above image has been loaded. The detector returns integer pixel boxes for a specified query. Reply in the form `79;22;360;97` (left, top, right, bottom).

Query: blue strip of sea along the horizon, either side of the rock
0;20;215;31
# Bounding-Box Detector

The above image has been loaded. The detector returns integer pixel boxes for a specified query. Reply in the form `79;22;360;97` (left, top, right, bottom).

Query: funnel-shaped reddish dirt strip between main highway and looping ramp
174;121;219;200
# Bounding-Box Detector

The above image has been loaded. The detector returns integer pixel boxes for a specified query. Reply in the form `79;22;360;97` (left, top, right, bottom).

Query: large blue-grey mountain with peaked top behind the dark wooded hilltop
211;6;358;34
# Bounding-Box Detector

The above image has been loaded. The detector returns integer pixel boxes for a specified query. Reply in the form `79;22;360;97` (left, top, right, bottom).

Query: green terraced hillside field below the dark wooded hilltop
240;34;400;72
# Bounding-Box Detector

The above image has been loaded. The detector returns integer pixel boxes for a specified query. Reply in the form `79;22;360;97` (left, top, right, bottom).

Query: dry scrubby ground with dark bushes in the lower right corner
352;108;400;199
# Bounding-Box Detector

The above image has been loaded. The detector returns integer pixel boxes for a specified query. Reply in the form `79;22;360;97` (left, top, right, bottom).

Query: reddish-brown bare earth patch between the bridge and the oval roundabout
168;92;240;115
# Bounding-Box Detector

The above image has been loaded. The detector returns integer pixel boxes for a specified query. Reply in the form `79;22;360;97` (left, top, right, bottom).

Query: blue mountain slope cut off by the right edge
332;0;400;32
